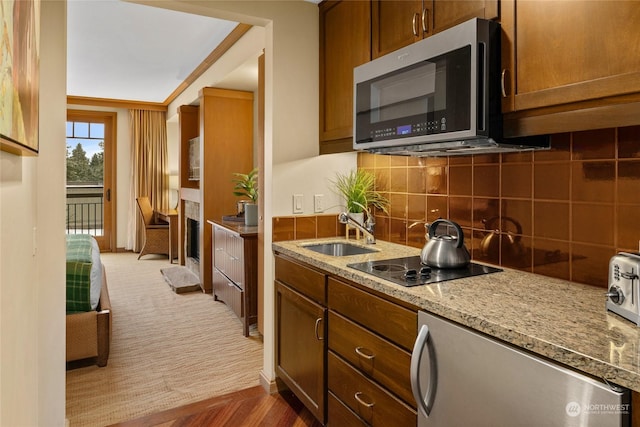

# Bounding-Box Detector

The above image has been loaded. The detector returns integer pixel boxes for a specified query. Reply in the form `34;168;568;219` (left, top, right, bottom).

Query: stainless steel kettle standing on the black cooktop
420;219;471;268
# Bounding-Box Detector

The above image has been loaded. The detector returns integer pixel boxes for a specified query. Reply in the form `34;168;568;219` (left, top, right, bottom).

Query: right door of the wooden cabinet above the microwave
432;0;499;33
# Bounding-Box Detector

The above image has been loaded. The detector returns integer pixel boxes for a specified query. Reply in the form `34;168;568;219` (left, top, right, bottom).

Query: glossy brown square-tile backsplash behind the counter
273;126;640;290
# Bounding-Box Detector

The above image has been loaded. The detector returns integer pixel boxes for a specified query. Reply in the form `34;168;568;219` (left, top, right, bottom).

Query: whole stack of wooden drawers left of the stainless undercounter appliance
327;277;418;426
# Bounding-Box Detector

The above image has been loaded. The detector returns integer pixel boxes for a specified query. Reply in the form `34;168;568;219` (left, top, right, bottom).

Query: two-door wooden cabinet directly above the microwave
371;0;498;58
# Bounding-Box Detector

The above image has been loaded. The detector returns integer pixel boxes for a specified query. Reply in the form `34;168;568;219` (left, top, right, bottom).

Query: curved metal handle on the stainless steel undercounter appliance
410;325;438;418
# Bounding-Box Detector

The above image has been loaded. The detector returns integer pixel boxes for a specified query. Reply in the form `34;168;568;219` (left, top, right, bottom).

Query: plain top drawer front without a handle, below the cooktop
327;277;418;350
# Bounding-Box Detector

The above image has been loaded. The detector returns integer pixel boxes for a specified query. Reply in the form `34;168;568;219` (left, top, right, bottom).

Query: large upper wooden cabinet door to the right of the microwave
502;0;640;112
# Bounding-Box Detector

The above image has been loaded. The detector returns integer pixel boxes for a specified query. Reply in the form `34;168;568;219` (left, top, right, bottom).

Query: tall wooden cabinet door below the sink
275;281;327;424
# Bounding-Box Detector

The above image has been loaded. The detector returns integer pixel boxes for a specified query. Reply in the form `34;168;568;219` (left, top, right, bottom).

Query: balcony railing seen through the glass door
67;184;104;236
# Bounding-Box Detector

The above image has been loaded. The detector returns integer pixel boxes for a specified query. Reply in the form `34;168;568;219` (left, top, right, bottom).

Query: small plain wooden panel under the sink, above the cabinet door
275;256;326;305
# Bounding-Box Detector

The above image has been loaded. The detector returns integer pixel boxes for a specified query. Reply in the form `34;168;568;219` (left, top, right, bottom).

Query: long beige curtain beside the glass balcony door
127;110;169;252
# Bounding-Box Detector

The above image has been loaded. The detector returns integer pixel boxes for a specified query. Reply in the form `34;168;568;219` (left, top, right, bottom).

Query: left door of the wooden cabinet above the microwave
371;0;424;58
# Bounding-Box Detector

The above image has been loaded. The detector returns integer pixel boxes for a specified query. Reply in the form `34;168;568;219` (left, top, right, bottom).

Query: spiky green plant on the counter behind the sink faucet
333;169;389;224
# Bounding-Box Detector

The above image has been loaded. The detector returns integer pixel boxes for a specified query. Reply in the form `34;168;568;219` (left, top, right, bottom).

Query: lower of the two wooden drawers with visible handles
328;351;417;426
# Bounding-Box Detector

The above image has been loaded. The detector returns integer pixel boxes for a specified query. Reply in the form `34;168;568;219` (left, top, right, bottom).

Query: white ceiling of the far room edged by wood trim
67;0;248;103
